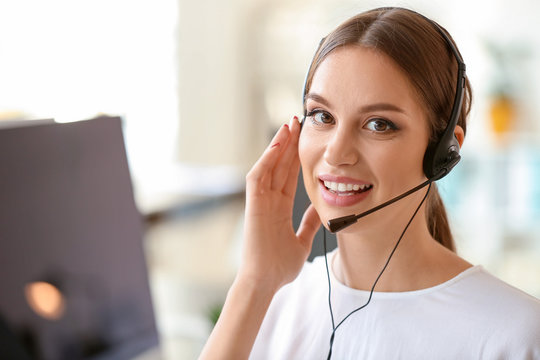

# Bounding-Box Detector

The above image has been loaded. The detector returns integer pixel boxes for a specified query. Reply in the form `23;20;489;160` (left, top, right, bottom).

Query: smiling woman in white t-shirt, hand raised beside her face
201;8;540;359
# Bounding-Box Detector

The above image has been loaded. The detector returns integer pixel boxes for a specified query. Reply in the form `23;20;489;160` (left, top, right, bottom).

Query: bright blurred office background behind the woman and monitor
0;0;540;359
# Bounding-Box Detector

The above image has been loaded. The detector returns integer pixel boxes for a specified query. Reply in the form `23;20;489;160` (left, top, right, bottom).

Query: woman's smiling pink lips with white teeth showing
319;175;373;207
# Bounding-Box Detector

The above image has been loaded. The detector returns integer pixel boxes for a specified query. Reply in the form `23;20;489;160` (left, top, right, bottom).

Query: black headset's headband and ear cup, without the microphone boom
302;7;466;181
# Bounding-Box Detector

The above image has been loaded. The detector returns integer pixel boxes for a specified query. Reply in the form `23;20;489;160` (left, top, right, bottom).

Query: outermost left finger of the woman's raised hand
246;125;289;193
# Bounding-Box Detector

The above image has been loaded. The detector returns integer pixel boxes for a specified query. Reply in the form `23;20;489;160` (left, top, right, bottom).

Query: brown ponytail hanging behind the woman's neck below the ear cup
426;183;456;252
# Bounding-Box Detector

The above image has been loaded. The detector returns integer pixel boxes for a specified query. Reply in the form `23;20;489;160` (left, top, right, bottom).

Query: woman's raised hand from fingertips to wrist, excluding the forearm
239;117;320;290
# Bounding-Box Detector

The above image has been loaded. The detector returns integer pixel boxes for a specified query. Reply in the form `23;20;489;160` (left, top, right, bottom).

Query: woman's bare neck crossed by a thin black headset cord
332;183;471;292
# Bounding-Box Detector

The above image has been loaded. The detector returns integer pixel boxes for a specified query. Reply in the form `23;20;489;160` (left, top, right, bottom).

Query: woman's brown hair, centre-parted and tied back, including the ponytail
304;8;472;251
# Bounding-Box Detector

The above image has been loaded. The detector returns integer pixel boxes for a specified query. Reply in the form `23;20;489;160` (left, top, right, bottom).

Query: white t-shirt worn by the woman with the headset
250;253;540;360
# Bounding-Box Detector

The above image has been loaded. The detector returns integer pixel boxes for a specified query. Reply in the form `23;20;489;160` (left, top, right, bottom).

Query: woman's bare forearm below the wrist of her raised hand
199;278;275;360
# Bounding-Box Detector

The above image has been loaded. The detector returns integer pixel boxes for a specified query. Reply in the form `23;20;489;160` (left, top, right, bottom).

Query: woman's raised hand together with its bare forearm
199;118;321;360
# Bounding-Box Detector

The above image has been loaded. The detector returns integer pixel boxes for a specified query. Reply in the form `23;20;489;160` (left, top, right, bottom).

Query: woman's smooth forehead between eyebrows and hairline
309;46;423;112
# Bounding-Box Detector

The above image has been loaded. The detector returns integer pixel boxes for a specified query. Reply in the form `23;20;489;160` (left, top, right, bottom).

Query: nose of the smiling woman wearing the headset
324;126;359;166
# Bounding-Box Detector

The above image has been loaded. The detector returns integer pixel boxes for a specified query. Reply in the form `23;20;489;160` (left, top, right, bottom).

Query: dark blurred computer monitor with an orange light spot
0;117;158;360
